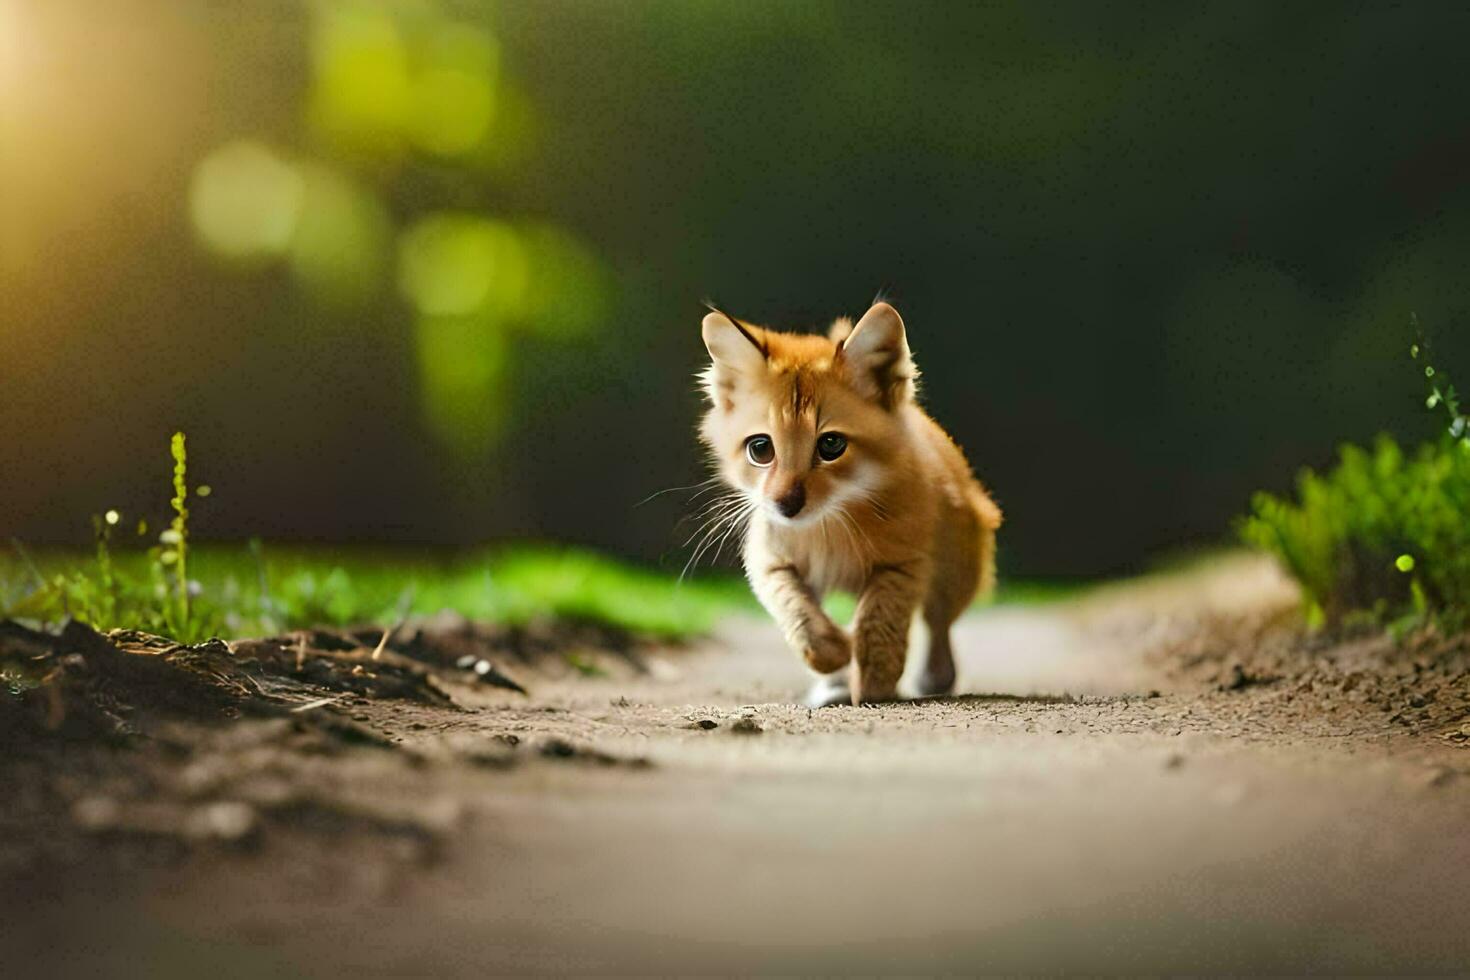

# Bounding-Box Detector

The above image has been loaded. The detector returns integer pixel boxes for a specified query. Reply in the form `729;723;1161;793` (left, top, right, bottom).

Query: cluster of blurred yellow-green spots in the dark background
190;0;612;458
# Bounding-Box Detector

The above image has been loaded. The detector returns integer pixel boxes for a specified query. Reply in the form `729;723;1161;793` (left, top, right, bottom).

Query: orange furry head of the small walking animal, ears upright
700;303;916;526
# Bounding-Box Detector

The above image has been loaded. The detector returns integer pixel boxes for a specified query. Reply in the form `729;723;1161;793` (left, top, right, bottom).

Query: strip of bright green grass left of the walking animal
0;544;753;641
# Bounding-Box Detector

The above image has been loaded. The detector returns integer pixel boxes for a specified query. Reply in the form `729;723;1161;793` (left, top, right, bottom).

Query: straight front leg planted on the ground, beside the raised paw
853;563;925;704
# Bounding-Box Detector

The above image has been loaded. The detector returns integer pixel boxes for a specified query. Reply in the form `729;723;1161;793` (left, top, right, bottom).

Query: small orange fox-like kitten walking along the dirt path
700;303;1001;705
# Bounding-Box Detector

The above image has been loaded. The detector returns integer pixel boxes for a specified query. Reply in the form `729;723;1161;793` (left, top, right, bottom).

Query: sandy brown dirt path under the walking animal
3;563;1470;976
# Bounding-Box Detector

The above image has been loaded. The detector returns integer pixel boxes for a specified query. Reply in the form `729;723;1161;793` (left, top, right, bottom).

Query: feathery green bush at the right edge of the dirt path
1241;339;1470;626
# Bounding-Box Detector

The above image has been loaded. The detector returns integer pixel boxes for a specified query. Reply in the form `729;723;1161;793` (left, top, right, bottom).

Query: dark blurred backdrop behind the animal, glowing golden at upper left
0;0;1470;576
